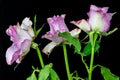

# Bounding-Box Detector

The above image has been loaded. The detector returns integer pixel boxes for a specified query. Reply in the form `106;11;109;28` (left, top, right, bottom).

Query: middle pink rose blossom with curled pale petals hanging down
42;14;81;54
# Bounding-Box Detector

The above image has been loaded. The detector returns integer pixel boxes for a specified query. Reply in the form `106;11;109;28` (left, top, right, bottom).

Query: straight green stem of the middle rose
63;43;72;80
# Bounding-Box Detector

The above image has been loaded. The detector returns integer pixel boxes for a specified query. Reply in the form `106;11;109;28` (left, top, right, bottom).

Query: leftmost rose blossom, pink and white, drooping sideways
6;17;34;65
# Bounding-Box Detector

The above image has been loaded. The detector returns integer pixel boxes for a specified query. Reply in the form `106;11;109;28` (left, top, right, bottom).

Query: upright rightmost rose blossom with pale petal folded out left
71;5;114;32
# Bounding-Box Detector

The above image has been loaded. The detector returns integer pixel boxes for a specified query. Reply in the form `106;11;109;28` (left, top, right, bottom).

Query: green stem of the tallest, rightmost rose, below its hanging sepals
88;46;94;80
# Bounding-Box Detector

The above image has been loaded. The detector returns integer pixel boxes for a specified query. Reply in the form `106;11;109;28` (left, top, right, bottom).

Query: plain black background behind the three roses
0;0;120;80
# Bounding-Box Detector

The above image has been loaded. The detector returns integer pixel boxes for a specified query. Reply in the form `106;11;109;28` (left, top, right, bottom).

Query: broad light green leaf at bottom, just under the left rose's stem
38;63;52;80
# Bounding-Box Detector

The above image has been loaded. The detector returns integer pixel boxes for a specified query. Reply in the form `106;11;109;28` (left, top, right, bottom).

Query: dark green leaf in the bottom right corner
101;66;119;80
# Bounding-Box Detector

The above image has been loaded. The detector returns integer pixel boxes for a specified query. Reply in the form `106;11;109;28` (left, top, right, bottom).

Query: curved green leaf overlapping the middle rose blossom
59;32;81;53
